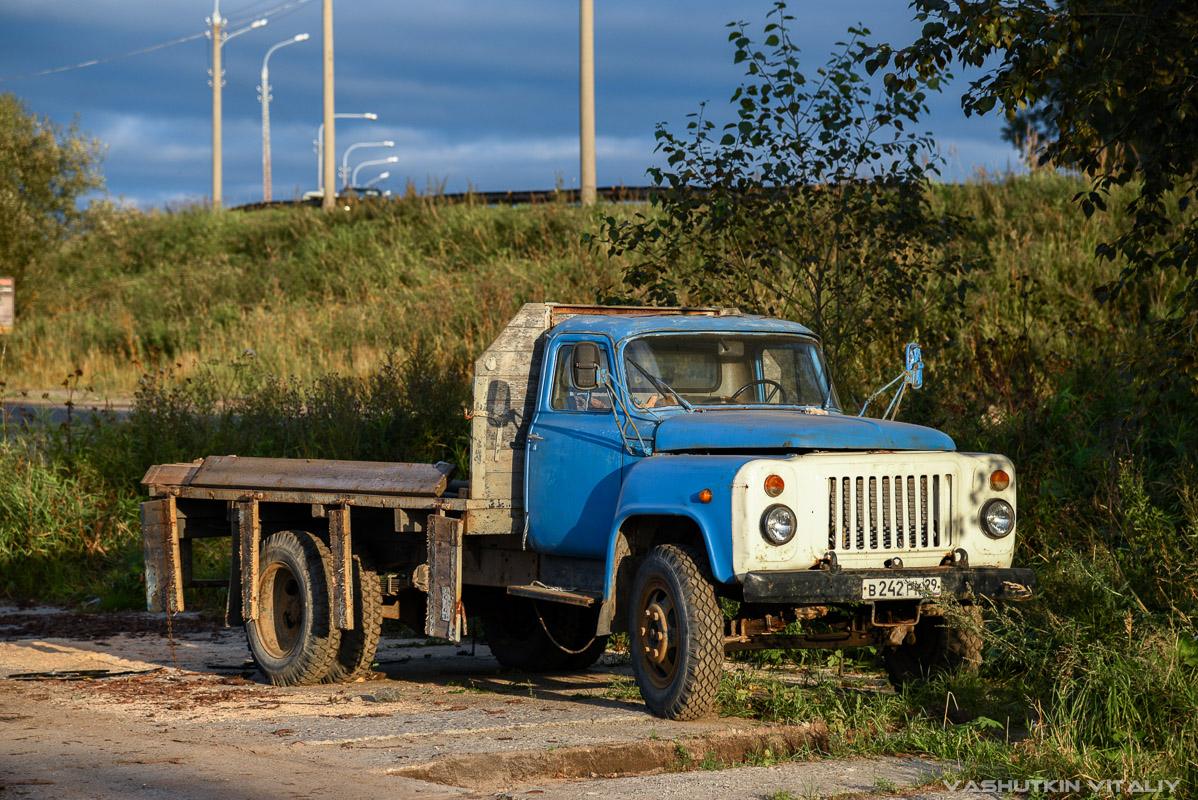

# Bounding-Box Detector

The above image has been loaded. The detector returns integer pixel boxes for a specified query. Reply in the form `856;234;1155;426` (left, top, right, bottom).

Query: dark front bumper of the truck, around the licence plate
744;566;1036;604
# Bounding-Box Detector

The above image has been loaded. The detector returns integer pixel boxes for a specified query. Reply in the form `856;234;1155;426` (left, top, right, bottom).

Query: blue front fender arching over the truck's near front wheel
604;455;754;600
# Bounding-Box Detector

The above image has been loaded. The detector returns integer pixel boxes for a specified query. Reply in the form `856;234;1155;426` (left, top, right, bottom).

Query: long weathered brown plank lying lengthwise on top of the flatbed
187;455;454;497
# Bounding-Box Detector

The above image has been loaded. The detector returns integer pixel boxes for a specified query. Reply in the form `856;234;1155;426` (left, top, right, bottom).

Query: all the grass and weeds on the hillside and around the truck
0;172;1198;790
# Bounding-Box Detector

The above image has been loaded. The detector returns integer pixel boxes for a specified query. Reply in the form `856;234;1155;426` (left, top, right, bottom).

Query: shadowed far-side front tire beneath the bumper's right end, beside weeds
882;606;982;689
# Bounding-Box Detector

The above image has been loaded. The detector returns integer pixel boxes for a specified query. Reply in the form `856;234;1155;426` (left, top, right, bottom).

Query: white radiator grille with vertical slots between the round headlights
828;473;952;552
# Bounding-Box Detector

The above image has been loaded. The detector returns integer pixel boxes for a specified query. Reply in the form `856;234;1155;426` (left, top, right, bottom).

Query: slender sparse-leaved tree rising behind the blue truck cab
589;2;960;392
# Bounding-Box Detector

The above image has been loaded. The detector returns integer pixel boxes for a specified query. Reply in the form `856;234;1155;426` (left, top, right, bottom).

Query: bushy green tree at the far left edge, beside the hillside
0;93;104;281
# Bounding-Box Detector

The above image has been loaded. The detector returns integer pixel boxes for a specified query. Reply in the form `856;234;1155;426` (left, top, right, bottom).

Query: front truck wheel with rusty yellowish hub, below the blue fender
628;545;724;720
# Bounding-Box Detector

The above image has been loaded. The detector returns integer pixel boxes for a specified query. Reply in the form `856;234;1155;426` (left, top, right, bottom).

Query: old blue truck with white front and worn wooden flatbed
143;303;1035;720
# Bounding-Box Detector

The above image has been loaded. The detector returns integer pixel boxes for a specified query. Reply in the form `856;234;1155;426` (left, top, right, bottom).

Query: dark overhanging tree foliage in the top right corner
873;0;1198;387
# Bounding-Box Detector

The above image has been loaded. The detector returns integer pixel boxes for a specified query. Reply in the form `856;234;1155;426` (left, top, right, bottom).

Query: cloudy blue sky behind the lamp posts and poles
0;0;1016;207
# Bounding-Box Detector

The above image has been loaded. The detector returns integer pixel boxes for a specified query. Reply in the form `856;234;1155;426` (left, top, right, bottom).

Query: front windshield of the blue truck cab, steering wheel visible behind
624;333;840;410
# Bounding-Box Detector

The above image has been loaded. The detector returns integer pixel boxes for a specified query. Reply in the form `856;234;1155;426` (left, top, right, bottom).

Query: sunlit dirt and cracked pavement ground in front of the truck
0;606;977;800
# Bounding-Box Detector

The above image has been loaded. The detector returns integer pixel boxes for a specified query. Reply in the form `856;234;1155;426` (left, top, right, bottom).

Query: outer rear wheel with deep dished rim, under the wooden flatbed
246;531;341;686
